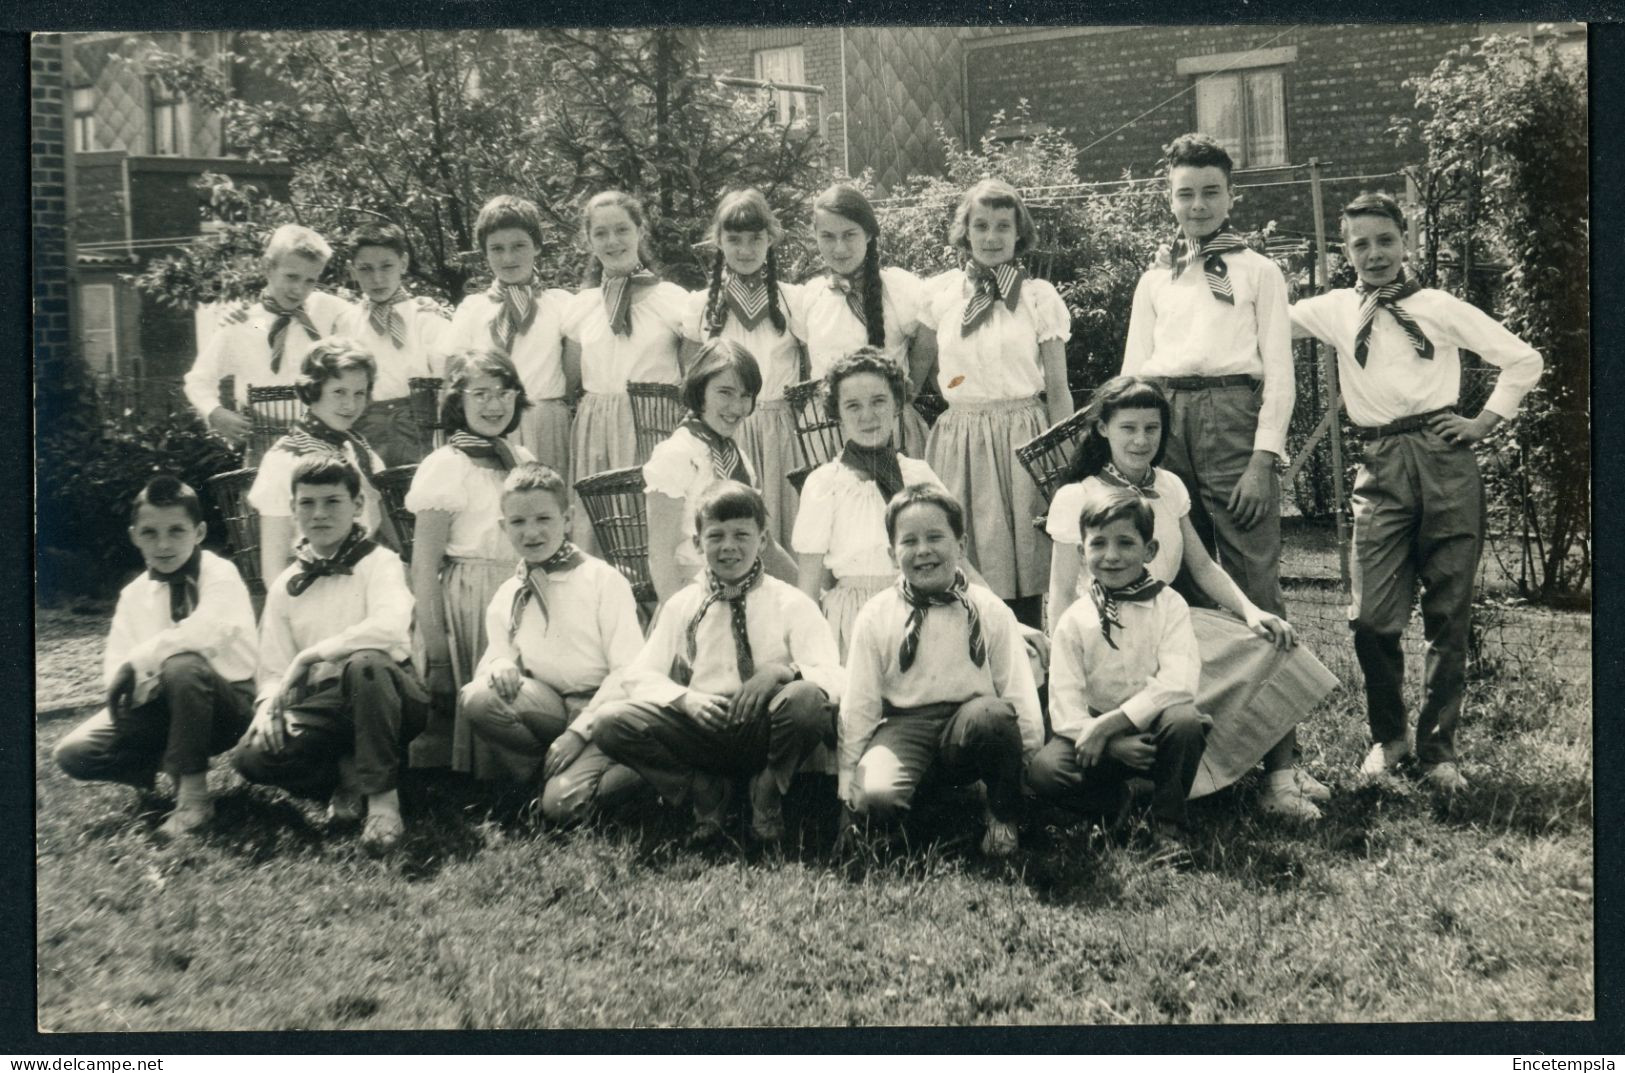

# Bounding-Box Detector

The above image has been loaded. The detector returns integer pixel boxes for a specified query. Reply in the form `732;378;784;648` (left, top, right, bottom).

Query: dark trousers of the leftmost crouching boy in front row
52;652;254;785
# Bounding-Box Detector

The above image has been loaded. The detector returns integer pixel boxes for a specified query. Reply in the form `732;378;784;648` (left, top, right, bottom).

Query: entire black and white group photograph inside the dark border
31;20;1606;1049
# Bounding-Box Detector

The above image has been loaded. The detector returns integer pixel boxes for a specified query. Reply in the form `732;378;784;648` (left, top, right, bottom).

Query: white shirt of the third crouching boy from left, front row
475;556;644;696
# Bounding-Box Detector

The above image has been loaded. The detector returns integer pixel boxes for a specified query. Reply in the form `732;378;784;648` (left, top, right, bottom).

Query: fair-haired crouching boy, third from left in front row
462;462;644;782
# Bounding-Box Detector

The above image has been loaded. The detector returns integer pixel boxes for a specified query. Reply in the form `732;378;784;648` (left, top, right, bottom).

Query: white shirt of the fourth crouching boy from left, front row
622;574;847;704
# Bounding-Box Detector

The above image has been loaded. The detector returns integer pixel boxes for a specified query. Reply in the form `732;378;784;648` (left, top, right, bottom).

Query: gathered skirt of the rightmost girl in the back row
925;395;1050;600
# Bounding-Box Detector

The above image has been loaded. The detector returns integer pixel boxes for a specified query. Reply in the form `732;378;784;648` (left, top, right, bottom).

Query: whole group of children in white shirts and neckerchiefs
57;135;1541;860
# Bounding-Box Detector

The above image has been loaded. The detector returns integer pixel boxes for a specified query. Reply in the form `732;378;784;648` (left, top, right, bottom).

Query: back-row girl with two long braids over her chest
683;189;803;546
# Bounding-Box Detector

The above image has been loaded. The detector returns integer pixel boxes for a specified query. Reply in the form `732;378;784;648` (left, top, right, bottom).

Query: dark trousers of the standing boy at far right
1349;428;1484;764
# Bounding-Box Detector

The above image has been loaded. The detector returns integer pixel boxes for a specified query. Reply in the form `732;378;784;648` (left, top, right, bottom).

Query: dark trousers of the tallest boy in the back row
1159;377;1287;616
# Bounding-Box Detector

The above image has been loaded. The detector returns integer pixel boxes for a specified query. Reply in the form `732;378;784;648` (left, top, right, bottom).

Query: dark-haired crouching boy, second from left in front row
232;454;429;852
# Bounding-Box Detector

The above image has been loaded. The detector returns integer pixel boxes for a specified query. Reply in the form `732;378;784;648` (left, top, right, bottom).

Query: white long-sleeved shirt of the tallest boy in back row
1123;250;1297;458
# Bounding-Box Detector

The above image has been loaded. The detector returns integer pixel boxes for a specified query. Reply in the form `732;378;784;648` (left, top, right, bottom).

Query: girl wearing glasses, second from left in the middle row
406;350;535;777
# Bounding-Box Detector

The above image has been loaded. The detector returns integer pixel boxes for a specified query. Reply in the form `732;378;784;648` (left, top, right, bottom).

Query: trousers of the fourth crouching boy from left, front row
593;681;829;805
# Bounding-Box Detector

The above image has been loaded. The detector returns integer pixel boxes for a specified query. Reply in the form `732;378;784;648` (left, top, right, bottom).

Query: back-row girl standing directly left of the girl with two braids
564;190;689;487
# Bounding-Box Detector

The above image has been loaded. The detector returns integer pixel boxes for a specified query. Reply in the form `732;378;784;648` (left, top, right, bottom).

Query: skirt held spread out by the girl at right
1191;608;1337;798
